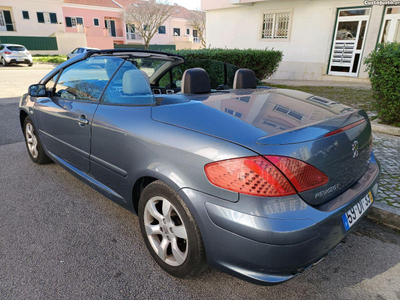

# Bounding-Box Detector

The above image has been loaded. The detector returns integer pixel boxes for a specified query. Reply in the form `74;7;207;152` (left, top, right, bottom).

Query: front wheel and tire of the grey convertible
24;117;51;165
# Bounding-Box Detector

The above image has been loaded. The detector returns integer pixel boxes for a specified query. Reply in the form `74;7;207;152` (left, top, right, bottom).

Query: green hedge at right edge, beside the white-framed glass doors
364;43;400;126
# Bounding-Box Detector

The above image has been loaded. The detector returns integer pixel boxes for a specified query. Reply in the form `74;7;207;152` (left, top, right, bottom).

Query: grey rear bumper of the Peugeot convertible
179;151;380;285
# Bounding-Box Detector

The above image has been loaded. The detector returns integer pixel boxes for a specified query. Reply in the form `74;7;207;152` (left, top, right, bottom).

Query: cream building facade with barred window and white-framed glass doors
202;0;400;81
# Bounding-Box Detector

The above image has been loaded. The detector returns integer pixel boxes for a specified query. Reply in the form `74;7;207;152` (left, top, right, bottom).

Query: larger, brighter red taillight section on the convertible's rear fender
204;156;296;197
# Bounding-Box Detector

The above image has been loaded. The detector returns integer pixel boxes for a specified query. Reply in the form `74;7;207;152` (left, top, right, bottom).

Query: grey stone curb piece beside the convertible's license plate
367;202;400;231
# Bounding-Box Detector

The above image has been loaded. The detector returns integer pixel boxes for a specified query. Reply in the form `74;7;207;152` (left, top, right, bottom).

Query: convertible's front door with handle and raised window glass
35;57;122;172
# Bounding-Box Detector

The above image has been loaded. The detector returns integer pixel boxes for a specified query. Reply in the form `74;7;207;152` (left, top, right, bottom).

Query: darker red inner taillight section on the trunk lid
266;156;329;192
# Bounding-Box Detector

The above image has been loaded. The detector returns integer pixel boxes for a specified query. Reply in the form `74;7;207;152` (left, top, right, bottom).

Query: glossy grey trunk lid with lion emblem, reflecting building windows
152;89;372;205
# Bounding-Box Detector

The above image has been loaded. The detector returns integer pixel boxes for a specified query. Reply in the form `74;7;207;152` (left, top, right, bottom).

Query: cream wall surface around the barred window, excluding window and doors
202;0;383;80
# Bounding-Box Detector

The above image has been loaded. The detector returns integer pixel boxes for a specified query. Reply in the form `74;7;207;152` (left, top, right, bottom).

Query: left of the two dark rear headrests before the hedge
182;68;211;94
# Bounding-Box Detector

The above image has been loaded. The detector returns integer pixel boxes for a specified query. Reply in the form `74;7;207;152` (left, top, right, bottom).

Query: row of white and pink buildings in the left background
0;0;205;54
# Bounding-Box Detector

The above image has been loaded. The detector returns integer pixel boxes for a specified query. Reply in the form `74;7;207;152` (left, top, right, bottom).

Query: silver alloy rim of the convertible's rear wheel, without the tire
143;197;189;266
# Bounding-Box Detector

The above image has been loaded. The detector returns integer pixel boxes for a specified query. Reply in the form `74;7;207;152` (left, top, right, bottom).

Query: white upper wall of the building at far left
0;0;63;36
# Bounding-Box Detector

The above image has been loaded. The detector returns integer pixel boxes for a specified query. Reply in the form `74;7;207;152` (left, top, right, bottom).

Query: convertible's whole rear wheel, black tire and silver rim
138;180;207;278
